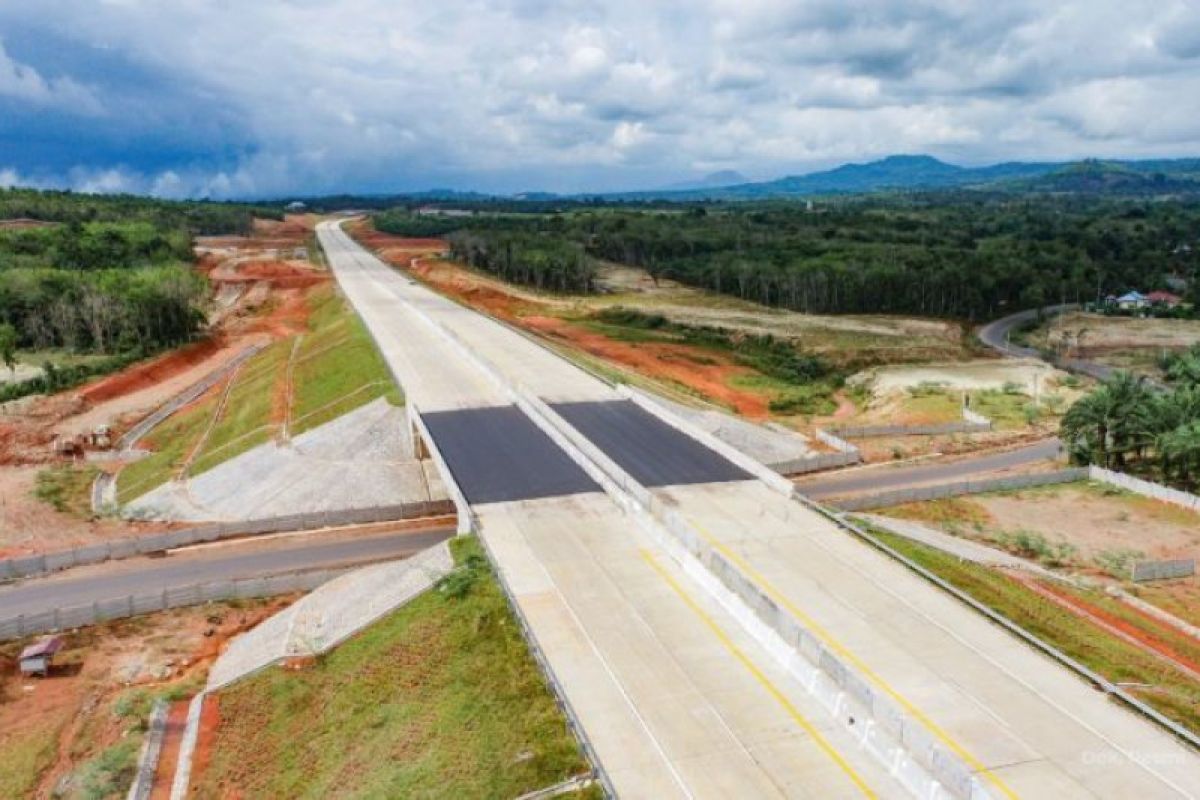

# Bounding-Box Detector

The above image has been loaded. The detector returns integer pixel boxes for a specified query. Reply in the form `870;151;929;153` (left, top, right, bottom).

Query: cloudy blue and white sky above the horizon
0;0;1200;197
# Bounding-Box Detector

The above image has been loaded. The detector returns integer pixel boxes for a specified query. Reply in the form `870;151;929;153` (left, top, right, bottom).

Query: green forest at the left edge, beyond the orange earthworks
0;190;278;399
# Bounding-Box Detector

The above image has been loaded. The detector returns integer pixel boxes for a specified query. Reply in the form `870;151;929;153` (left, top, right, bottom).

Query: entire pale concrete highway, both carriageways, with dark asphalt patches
318;220;1200;798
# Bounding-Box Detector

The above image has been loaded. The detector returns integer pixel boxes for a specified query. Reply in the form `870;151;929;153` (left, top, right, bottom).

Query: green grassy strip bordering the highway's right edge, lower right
872;522;1200;732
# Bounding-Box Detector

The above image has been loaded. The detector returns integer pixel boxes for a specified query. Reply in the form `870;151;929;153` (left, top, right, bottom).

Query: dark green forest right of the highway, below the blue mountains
374;191;1200;320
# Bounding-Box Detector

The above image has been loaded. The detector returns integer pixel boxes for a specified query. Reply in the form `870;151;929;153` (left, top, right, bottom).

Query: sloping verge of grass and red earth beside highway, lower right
875;533;1200;732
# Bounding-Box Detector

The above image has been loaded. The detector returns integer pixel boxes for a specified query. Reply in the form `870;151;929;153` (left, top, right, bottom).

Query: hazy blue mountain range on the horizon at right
602;156;1200;200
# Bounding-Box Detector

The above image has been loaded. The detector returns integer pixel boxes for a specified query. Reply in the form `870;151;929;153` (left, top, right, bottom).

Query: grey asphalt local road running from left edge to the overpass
0;527;454;616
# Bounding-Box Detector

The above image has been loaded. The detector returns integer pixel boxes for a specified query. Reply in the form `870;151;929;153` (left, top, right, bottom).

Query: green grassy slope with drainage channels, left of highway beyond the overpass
118;287;403;503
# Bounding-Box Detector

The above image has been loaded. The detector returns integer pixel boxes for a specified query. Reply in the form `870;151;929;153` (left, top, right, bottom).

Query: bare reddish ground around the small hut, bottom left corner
0;600;288;800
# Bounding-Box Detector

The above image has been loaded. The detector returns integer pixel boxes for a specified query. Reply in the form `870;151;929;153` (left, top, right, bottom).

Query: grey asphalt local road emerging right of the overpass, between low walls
797;439;1062;499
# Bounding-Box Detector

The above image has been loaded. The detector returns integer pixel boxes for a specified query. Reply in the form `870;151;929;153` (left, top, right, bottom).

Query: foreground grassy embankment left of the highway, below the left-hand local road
194;540;598;798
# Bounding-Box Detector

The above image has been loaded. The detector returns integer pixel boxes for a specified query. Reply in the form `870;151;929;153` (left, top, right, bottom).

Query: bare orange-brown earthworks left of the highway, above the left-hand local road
0;217;331;558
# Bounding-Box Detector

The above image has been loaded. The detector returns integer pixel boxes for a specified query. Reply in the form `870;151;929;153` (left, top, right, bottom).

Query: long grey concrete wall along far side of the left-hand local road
0;503;461;583
